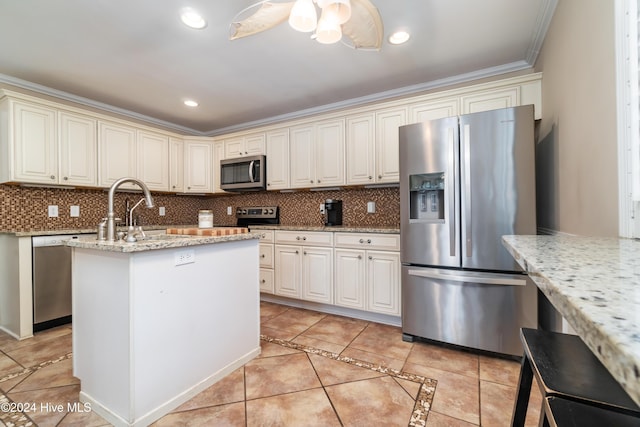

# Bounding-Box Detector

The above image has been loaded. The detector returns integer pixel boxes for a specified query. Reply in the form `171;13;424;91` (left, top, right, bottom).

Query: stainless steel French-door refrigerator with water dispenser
400;105;537;356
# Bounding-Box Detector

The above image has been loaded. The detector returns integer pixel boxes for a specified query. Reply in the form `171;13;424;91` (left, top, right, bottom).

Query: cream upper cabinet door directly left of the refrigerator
376;107;407;183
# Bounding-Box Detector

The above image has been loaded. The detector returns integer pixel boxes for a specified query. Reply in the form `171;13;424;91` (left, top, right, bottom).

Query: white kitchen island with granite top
67;233;260;426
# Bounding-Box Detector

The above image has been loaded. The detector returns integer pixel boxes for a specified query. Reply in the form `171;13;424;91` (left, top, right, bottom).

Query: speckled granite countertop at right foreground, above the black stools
502;236;640;405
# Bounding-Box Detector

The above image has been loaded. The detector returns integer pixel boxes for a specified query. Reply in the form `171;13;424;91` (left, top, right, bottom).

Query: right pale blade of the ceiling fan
342;0;384;50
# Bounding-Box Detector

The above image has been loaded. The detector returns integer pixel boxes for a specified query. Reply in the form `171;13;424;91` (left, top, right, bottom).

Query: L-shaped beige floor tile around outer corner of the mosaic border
405;363;480;424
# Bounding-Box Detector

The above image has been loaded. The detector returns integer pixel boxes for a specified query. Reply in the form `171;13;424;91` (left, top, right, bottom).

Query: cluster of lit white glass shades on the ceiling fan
289;0;351;44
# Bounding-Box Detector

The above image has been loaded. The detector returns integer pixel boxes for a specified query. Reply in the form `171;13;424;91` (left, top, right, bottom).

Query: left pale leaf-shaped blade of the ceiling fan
229;1;295;40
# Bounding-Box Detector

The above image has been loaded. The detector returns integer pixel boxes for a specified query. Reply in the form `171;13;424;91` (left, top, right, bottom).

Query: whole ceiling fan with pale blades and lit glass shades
229;0;383;50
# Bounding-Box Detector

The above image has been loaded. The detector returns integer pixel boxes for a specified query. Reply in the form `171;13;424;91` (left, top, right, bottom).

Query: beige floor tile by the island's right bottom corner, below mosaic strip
245;353;322;399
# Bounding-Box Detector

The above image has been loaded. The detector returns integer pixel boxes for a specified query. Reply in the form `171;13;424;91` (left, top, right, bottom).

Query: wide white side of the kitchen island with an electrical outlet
131;240;260;420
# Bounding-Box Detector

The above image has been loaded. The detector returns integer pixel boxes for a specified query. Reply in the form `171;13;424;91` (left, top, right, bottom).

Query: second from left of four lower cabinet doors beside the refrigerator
302;246;333;304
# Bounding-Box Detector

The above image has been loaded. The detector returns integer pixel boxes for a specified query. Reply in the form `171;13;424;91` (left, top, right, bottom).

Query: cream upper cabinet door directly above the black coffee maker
315;119;345;187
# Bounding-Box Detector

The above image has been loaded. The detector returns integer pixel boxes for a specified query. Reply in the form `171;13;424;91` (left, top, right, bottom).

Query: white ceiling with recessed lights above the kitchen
0;0;557;135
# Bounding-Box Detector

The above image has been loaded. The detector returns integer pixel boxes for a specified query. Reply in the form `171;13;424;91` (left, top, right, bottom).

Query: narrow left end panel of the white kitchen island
72;248;131;420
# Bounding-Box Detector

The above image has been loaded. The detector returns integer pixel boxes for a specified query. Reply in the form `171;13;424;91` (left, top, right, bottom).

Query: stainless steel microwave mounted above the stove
220;155;267;191
